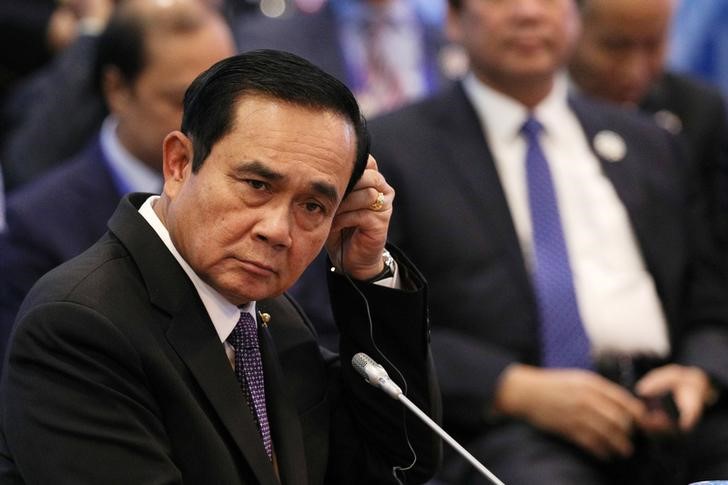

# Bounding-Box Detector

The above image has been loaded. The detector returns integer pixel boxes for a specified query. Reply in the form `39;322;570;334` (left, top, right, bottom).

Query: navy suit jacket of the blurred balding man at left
0;136;121;362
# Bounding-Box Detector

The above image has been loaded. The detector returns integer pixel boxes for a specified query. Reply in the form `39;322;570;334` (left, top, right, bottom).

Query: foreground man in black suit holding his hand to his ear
0;51;439;485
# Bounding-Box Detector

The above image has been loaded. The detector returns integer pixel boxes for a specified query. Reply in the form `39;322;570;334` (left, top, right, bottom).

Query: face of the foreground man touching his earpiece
162;95;356;305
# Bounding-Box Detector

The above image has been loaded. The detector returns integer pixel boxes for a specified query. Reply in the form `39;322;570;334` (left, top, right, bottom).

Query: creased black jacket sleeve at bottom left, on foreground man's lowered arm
0;302;181;484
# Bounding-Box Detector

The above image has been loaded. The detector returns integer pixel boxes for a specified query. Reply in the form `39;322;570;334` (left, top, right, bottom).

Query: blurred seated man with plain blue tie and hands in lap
371;0;728;485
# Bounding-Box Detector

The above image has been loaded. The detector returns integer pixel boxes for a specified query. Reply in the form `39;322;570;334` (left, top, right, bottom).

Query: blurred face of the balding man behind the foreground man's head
112;21;235;171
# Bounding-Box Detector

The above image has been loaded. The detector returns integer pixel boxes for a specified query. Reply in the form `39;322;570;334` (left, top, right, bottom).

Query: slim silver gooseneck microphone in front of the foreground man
351;352;505;485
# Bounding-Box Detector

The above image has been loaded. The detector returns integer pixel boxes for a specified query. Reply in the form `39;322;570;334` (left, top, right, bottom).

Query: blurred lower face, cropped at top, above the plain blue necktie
448;0;578;92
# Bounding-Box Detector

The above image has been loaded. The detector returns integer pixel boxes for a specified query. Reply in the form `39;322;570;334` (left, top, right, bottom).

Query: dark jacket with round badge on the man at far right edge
640;73;728;251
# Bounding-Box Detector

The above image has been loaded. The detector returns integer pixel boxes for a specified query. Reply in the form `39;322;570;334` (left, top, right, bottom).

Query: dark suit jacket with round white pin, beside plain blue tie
370;85;728;434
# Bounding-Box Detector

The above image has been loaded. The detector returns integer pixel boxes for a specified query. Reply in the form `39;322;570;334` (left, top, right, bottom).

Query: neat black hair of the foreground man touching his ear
181;50;369;194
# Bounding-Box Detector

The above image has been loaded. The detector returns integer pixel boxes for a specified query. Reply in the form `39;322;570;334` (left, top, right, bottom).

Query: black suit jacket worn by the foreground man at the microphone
0;194;439;485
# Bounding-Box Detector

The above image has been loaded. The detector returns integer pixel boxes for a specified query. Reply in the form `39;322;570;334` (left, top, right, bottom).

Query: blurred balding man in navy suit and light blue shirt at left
0;0;235;366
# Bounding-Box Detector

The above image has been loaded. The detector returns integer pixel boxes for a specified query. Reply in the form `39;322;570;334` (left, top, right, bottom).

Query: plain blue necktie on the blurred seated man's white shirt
522;117;592;369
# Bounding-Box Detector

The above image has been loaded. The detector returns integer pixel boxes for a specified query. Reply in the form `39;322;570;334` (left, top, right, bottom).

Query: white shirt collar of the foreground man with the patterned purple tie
139;195;257;342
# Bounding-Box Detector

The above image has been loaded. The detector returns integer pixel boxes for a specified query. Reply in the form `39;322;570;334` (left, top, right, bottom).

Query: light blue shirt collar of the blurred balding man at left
100;115;162;195
